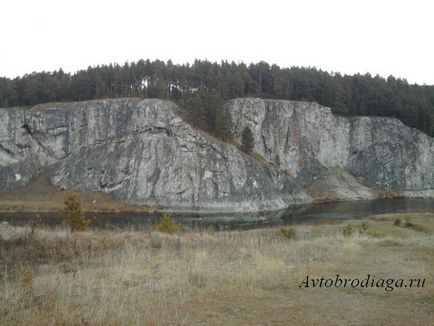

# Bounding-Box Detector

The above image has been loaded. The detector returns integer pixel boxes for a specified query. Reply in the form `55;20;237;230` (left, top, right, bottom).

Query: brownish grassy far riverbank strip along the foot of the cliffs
0;173;434;215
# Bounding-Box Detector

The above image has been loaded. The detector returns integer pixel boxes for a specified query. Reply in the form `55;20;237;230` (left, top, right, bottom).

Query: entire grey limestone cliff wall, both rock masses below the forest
0;99;434;211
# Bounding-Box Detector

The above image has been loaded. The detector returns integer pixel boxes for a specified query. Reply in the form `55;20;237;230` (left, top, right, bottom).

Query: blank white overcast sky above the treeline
0;0;434;84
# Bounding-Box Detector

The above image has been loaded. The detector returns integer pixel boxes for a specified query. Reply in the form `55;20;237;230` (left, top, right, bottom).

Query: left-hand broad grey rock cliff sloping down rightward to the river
0;99;308;211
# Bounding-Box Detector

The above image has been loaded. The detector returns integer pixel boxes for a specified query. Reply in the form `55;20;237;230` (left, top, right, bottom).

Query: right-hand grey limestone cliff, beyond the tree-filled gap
229;99;434;191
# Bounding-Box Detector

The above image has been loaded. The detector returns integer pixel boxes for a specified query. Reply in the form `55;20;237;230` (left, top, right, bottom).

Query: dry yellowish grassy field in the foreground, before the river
0;213;434;325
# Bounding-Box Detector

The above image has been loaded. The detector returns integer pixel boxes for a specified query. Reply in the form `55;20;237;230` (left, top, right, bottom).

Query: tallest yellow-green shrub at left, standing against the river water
61;192;90;232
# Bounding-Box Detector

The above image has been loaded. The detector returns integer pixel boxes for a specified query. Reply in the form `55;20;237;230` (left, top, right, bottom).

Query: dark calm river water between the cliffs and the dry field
0;199;434;230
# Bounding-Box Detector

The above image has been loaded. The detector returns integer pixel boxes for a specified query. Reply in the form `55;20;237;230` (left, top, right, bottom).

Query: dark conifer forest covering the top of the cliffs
0;60;434;136
